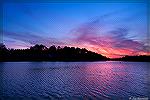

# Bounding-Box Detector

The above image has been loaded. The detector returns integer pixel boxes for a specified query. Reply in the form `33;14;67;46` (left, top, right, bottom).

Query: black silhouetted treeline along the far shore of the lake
0;43;150;62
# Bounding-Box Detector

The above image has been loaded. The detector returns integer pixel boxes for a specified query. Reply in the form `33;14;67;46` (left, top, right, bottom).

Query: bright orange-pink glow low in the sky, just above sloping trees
75;44;150;58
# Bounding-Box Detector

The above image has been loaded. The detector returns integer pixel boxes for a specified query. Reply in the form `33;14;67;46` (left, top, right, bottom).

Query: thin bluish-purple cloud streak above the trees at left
3;31;65;46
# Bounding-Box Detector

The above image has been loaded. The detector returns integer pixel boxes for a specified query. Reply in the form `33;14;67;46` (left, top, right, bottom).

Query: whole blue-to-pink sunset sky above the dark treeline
2;1;150;58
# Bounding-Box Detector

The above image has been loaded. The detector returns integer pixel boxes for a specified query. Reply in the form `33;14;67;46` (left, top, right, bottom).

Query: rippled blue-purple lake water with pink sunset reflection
0;62;150;100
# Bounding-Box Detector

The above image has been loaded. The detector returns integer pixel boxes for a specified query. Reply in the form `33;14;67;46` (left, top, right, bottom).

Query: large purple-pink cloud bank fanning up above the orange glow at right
70;16;150;58
